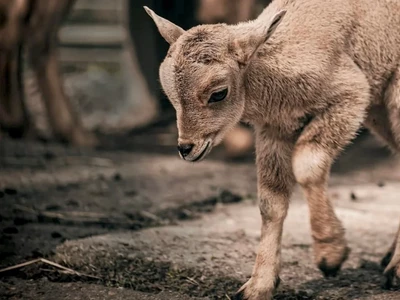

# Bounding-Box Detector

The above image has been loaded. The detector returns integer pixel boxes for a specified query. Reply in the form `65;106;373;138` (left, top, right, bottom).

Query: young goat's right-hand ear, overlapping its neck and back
234;10;286;65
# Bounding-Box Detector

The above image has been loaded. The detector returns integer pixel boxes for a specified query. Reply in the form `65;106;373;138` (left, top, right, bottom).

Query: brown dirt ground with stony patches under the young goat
0;125;400;300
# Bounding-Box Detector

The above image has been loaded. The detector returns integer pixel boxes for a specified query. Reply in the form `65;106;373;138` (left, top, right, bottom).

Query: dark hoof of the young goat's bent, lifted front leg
316;246;350;278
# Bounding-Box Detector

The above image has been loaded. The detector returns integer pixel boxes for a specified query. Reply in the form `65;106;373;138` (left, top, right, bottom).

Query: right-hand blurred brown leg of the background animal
26;0;97;147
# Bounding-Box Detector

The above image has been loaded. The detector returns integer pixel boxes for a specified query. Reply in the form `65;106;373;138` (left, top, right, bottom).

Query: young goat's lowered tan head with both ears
145;7;285;162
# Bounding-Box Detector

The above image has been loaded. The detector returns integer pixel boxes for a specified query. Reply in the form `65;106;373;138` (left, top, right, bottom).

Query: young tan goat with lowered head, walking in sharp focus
146;0;400;300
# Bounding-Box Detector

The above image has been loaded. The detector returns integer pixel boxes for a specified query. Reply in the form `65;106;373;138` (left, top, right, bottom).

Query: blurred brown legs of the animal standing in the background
0;0;96;146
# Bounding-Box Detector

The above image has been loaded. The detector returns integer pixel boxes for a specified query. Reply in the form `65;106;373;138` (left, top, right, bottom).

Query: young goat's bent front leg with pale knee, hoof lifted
293;89;368;276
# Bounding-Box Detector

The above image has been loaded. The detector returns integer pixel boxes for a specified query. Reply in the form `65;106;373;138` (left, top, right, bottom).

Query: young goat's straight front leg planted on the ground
235;128;295;300
